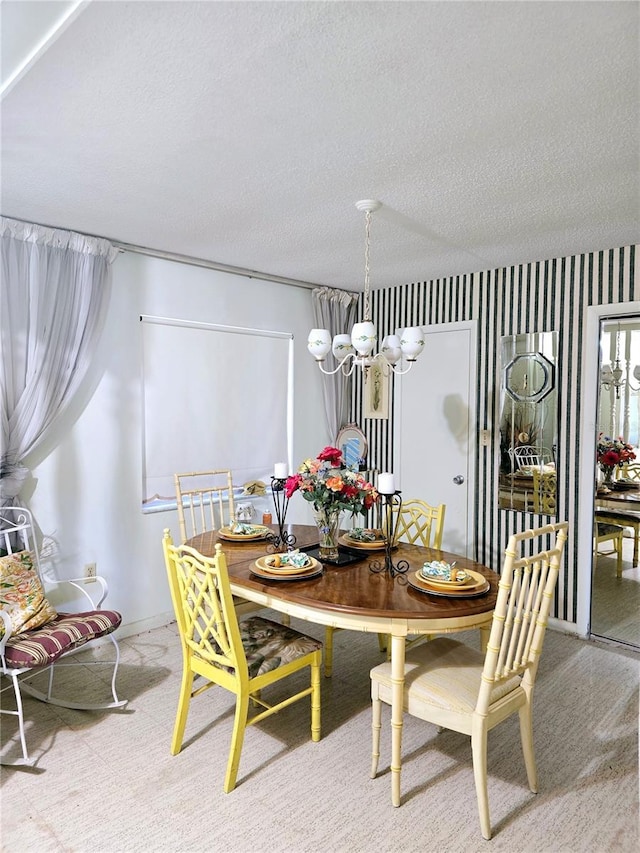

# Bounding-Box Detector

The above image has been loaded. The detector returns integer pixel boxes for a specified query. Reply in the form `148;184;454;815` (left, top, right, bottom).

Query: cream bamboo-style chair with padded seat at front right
371;522;568;839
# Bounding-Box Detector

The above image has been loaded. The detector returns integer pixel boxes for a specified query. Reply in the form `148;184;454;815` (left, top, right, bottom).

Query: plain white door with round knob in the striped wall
395;321;476;556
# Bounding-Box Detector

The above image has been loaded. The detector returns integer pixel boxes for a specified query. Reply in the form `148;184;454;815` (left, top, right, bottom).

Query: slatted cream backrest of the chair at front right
476;521;569;715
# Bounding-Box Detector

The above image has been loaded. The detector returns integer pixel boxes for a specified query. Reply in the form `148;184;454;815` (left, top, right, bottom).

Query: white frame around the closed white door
393;320;478;556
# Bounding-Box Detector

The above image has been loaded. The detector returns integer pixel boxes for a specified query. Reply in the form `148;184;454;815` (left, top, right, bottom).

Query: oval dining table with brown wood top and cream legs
185;525;500;806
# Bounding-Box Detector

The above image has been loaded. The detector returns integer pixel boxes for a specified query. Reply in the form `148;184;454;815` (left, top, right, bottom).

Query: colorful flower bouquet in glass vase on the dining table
284;447;378;515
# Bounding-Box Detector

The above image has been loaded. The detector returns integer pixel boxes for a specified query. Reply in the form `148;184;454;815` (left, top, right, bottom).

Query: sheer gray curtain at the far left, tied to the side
0;217;117;507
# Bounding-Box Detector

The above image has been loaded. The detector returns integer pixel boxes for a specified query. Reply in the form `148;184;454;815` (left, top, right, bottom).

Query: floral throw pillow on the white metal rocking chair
0;551;57;637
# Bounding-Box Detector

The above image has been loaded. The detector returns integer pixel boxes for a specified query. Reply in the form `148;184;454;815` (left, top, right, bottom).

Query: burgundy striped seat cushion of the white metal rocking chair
5;610;122;669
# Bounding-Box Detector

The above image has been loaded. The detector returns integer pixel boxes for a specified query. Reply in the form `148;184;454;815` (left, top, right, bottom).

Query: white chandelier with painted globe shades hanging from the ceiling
307;199;424;376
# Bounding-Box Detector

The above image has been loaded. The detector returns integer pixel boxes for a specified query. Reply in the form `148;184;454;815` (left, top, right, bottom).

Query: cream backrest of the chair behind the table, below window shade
174;468;236;542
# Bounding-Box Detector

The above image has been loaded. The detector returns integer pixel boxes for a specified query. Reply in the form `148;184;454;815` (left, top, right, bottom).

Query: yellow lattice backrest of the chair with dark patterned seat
162;529;247;679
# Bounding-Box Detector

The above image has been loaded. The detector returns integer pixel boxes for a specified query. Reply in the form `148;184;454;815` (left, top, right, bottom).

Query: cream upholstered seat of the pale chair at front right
371;637;520;714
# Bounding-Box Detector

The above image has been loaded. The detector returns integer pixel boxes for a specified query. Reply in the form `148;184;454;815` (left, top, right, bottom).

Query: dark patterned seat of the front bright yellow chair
239;616;322;678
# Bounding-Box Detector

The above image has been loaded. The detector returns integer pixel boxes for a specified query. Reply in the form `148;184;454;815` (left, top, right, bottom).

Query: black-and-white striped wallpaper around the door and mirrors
351;246;640;623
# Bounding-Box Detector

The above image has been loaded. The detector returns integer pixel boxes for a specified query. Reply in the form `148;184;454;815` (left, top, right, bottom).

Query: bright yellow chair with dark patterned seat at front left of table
163;529;322;793
